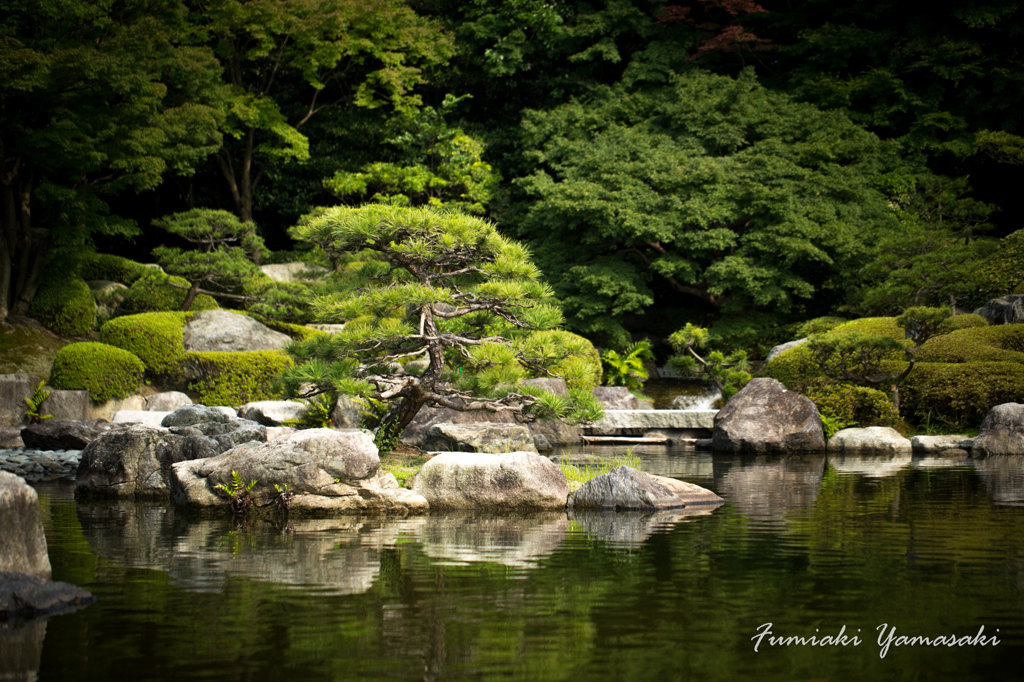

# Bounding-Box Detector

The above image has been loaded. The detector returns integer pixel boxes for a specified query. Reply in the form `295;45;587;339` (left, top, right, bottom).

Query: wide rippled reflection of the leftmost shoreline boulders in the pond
78;502;424;595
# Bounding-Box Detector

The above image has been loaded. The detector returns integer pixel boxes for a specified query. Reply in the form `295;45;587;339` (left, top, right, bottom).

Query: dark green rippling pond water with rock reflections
18;449;1024;681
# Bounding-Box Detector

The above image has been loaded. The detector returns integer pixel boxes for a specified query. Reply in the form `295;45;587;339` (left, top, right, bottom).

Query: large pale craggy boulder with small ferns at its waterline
171;429;428;514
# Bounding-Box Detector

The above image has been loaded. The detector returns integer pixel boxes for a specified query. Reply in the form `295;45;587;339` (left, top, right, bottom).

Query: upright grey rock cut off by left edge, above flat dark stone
0;471;50;580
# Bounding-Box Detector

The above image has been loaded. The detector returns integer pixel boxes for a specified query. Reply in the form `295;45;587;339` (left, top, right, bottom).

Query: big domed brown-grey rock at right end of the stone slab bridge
712;378;825;454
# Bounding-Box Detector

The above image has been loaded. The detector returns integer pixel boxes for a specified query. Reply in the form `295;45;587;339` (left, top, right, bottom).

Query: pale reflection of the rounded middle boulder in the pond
417;512;569;567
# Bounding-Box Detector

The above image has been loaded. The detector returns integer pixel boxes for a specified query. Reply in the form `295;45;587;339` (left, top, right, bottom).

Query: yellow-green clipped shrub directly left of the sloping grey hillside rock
99;312;188;376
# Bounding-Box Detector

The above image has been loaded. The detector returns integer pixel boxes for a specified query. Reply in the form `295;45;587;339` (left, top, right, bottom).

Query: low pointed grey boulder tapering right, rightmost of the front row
568;466;725;511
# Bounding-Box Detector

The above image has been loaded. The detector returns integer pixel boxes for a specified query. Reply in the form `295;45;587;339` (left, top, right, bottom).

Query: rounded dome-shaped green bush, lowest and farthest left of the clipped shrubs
50;341;145;402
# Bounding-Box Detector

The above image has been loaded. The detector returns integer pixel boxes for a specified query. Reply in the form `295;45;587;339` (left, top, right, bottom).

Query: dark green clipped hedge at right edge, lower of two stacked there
900;361;1024;428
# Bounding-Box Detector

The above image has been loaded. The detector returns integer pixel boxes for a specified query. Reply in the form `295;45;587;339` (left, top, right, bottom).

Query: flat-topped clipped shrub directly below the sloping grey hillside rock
184;350;293;406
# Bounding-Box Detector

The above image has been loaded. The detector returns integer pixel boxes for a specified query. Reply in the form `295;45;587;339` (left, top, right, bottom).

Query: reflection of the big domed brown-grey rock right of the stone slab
712;455;825;519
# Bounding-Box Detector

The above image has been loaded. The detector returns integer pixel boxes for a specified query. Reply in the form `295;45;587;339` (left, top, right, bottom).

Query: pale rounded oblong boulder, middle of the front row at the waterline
413;453;569;511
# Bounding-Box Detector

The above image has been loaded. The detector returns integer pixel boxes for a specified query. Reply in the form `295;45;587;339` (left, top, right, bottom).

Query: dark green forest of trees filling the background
6;0;1024;357
